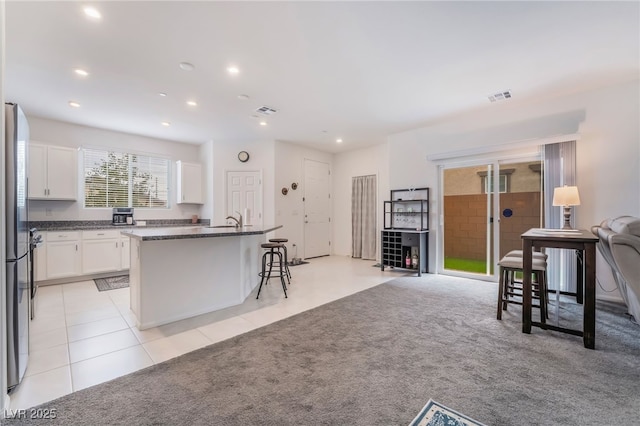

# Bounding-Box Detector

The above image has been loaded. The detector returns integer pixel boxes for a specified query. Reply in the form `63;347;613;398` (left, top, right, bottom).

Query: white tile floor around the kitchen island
10;256;402;410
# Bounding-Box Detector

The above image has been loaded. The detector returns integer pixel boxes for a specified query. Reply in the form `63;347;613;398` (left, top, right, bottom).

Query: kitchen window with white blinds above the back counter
83;148;171;208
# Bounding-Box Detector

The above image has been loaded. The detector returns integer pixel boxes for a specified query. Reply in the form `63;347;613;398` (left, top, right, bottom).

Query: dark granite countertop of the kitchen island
121;225;282;241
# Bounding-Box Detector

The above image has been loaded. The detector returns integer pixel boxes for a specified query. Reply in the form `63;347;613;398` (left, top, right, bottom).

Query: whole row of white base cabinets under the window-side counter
34;229;130;281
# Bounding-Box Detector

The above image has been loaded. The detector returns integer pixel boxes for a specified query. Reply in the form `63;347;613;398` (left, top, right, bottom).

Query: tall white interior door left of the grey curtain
304;160;331;258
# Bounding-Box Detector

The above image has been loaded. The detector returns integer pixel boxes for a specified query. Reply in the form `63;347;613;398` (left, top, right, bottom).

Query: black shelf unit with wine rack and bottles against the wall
380;188;429;276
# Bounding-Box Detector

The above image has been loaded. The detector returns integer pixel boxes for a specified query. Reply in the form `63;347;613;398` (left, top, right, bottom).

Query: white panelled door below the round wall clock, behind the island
225;171;262;226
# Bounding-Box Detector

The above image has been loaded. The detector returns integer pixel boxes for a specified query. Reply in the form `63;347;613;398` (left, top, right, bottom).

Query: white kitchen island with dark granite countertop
122;225;282;330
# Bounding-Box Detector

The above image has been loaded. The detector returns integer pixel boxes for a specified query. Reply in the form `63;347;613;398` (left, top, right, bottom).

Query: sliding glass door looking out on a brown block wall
439;156;544;279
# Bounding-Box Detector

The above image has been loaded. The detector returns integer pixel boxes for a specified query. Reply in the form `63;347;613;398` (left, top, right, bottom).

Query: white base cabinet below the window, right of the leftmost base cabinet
82;230;121;275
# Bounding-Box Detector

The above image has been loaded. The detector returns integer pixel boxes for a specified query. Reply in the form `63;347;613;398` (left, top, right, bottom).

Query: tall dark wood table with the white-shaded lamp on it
521;228;598;349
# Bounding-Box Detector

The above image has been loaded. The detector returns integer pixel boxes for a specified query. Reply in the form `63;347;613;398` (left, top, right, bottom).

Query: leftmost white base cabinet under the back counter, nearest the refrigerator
46;231;81;279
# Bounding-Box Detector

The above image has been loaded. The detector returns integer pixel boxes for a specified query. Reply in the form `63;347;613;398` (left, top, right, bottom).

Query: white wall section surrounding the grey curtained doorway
333;143;390;260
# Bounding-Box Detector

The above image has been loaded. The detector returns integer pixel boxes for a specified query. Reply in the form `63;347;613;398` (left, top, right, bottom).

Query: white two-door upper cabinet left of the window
29;143;78;200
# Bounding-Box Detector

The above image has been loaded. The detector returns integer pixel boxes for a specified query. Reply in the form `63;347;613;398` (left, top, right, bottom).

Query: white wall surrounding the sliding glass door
389;80;640;298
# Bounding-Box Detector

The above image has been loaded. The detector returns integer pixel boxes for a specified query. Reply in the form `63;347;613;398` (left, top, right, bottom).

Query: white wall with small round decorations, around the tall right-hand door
273;141;332;258
